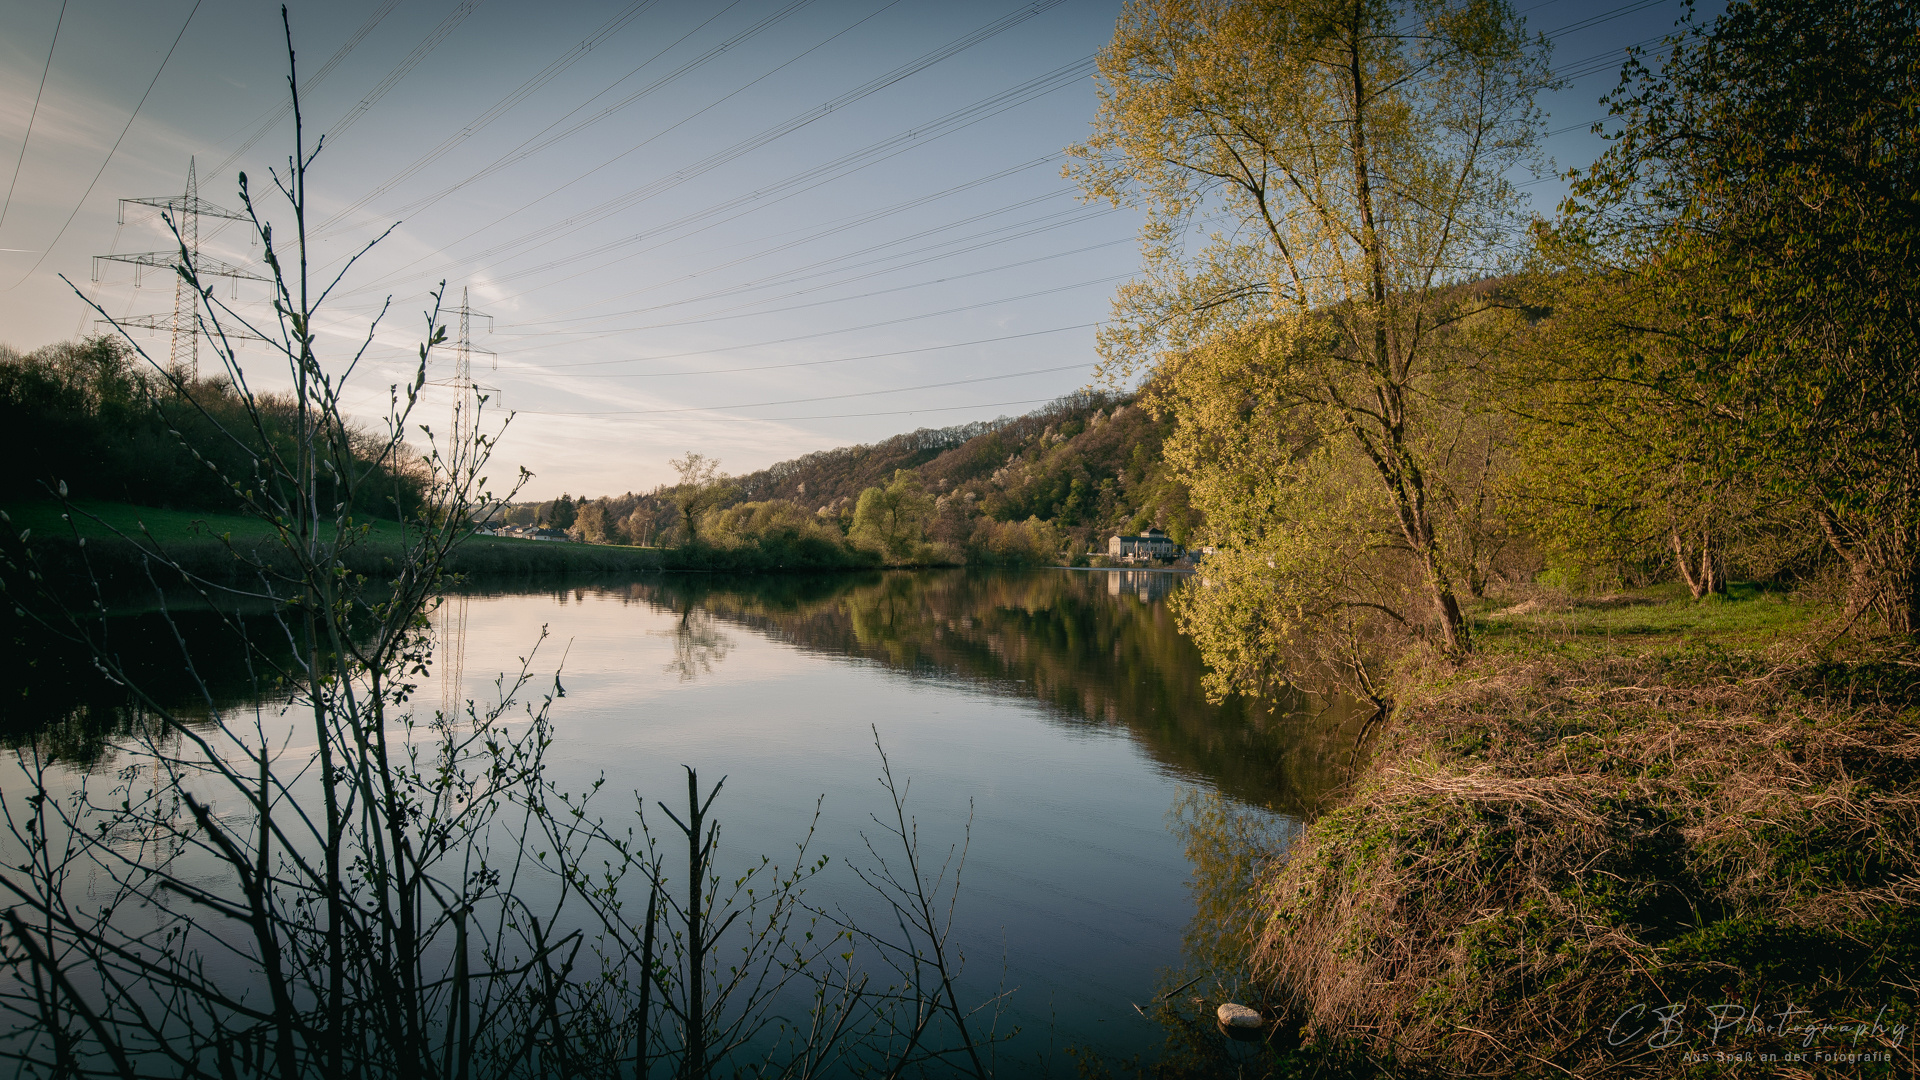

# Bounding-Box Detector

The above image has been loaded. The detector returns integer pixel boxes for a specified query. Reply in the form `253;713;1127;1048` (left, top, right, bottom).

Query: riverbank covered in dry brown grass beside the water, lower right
1254;590;1920;1076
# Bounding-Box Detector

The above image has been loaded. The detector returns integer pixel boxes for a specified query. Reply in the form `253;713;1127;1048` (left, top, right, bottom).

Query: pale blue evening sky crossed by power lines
0;0;1711;498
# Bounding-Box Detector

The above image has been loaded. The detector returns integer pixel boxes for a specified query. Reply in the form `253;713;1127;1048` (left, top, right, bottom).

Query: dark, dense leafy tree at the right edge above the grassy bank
1567;0;1920;634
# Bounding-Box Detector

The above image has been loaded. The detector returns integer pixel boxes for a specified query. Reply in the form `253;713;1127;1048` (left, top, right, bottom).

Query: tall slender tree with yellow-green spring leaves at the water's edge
1069;0;1548;667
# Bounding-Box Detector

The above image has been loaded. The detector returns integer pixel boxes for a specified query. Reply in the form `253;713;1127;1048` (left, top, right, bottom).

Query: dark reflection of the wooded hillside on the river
526;571;1363;817
